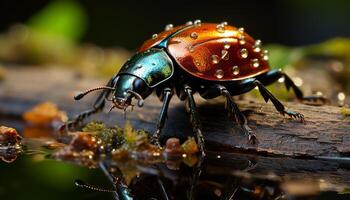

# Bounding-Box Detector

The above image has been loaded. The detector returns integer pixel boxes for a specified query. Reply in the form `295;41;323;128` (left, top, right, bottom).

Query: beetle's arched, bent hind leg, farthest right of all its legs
257;69;328;104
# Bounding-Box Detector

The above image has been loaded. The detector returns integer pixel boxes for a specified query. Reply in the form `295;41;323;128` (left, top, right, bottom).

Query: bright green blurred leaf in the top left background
28;0;87;41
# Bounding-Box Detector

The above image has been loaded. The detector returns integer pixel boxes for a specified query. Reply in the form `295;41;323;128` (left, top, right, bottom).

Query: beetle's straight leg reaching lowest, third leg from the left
184;85;205;157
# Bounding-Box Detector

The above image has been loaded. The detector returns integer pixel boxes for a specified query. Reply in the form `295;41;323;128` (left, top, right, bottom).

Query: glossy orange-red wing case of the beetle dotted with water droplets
141;23;269;81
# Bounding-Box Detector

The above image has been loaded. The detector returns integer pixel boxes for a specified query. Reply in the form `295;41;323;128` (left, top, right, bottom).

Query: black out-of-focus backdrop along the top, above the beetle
0;0;350;50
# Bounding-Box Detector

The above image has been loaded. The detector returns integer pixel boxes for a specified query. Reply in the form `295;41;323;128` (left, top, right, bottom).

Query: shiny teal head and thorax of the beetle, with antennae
75;48;174;110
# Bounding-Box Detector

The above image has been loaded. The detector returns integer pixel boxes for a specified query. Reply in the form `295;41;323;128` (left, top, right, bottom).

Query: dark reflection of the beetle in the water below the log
76;153;283;200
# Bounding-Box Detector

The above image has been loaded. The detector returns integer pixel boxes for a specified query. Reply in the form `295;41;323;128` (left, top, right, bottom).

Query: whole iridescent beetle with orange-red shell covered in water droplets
66;20;326;154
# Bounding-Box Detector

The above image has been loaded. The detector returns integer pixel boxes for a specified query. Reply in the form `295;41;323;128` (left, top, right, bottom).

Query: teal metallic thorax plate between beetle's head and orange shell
118;48;174;88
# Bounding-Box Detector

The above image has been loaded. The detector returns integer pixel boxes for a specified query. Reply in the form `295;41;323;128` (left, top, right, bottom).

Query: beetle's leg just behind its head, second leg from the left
151;88;173;146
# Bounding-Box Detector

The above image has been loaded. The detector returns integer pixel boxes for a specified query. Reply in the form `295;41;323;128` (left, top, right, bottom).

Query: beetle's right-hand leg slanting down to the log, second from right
253;80;304;122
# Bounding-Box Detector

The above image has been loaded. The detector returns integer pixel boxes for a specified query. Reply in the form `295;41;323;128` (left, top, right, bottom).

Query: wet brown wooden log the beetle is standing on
0;67;350;159
